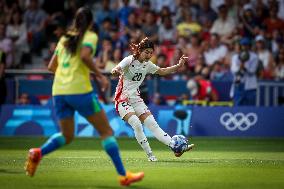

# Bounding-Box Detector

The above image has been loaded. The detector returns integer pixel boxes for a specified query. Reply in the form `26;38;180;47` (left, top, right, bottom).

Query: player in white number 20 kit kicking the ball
111;38;193;161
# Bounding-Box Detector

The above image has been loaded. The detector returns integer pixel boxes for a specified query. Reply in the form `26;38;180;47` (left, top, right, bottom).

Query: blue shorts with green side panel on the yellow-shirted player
53;92;102;119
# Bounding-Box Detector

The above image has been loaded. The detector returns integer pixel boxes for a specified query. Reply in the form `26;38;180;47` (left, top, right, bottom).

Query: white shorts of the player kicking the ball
116;99;149;118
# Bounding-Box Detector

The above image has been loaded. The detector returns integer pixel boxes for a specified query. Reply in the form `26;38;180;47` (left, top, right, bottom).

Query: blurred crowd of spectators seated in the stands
0;0;284;105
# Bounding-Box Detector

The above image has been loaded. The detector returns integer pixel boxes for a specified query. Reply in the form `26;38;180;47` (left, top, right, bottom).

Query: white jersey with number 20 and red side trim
114;55;160;103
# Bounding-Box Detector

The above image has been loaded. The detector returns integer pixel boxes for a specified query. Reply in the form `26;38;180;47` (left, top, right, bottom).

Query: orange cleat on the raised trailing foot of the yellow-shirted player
25;148;41;177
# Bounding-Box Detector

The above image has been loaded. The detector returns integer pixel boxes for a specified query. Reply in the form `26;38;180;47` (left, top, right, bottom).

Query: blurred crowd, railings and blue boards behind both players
0;0;284;137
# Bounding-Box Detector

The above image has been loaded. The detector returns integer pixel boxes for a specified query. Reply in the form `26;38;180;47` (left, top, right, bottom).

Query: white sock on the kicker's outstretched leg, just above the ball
144;115;171;146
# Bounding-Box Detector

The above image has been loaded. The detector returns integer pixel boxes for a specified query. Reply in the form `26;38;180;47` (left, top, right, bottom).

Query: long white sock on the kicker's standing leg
128;115;152;155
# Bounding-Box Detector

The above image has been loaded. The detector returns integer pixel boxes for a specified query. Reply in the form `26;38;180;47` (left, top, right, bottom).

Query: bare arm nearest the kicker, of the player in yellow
80;46;109;91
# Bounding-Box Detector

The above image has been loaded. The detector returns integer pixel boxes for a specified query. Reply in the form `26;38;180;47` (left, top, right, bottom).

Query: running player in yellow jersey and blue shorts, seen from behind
25;7;144;186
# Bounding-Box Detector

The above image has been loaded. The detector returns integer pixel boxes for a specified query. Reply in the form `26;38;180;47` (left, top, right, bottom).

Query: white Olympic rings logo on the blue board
220;112;258;131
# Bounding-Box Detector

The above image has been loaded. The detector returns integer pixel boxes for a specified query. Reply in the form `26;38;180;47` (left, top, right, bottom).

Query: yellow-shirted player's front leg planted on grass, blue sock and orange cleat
83;96;144;185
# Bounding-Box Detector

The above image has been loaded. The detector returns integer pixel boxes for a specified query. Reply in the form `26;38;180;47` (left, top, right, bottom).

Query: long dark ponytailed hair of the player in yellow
64;7;93;54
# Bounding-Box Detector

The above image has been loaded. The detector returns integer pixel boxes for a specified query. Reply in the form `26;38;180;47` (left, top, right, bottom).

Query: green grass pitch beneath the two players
0;137;284;189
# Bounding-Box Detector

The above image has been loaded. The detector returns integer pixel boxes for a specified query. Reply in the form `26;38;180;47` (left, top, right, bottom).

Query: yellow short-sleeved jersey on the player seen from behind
52;31;98;95
